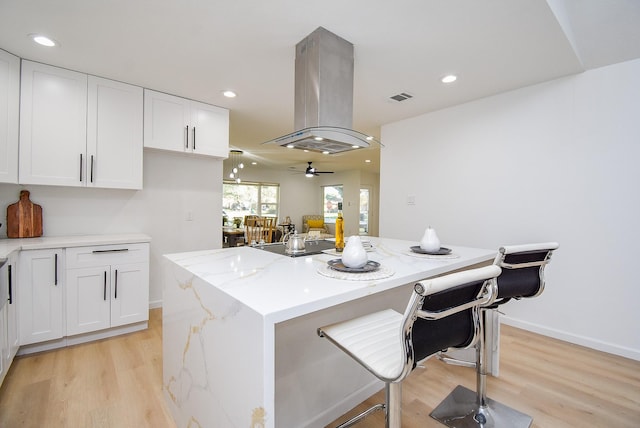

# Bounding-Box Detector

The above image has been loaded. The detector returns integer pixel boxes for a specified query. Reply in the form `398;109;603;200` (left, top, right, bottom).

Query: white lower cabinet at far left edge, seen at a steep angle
0;254;19;385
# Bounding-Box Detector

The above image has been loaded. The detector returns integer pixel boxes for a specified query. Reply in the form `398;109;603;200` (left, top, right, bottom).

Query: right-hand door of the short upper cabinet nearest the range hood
190;101;229;158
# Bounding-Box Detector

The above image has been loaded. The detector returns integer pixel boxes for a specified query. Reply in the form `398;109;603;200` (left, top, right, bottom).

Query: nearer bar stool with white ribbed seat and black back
318;265;501;428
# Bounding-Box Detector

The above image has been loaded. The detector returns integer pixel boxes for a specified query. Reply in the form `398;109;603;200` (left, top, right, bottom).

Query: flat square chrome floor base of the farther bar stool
430;385;533;428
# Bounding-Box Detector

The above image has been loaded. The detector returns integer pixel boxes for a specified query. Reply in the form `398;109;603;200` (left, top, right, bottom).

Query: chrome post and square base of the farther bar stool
430;310;533;428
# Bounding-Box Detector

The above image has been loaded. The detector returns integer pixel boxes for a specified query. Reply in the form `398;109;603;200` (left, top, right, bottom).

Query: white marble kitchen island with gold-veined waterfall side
163;238;495;428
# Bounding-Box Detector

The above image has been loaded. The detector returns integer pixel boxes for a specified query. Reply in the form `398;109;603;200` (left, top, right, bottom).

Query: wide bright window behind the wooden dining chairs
222;181;280;223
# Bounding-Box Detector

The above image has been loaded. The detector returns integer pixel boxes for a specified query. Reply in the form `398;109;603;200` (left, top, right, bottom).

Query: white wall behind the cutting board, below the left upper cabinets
0;149;222;306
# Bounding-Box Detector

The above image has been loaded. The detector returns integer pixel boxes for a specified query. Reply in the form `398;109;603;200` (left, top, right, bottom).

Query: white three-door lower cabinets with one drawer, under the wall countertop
15;237;149;354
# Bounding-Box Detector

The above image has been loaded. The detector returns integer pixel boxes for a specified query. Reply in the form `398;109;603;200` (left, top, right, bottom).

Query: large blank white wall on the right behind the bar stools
380;60;640;360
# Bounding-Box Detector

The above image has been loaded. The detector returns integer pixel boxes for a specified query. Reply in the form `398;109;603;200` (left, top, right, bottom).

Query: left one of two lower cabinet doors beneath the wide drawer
66;266;111;336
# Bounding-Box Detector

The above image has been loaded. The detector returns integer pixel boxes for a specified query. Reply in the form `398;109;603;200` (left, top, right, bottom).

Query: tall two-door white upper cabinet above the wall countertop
19;60;143;189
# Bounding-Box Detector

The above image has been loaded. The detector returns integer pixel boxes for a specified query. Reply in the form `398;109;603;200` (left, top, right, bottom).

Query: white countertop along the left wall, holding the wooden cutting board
0;233;151;258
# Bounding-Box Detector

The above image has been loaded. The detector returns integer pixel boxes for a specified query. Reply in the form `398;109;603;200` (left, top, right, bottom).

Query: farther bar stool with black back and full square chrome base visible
431;242;558;428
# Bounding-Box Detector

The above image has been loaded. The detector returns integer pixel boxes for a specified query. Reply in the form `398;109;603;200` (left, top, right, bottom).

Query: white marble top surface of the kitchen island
165;238;496;323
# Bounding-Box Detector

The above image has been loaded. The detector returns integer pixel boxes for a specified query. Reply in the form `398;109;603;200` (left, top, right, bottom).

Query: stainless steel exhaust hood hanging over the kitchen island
263;27;380;154
